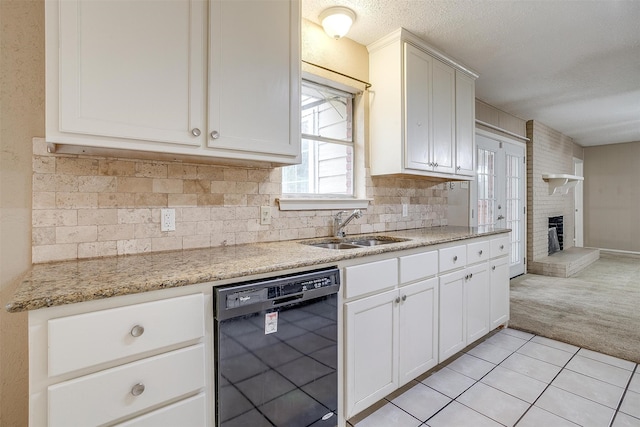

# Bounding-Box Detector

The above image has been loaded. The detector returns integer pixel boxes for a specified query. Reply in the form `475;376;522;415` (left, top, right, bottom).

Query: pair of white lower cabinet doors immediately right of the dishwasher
345;278;438;417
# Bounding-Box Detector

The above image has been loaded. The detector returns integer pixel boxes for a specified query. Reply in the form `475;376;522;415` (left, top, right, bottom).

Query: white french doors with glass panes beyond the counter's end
471;133;527;277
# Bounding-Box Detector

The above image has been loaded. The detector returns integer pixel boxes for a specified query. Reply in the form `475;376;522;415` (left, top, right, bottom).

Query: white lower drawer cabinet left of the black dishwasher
29;291;212;427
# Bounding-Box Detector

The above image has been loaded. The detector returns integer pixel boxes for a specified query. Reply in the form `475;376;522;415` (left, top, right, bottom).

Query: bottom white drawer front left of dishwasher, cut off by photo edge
116;393;207;427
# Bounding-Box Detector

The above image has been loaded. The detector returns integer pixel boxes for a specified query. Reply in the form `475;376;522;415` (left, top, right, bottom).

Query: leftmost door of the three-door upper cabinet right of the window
404;43;433;170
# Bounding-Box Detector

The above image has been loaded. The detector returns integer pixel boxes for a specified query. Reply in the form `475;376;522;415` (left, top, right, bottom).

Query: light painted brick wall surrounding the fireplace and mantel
527;120;580;273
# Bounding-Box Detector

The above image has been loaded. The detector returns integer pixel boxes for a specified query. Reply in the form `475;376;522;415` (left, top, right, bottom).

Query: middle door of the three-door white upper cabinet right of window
431;59;455;173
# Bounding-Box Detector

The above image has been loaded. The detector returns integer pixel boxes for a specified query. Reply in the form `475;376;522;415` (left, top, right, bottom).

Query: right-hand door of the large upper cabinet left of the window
207;0;300;156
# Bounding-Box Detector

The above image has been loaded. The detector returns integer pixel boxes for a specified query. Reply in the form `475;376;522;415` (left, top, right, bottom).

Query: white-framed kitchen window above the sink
281;80;368;208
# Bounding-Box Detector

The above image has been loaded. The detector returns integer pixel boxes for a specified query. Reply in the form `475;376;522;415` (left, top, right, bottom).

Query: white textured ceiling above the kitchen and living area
302;0;640;146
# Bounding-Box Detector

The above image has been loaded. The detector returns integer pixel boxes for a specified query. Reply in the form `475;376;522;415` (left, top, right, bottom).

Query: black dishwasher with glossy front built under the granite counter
214;267;340;427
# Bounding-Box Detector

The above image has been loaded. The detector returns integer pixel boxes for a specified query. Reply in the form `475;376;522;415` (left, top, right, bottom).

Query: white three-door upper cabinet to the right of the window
367;29;477;180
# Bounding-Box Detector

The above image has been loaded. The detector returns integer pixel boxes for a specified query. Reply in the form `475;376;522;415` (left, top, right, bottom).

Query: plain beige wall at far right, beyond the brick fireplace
584;141;640;252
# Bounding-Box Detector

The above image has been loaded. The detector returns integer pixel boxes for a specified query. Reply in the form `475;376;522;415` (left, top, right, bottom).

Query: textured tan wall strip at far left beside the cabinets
0;0;44;426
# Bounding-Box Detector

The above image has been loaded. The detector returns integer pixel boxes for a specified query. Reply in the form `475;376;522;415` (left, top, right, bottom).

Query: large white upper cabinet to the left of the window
45;0;300;164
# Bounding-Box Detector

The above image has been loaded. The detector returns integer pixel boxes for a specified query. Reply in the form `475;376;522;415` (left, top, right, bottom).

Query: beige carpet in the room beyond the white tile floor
509;253;640;363
